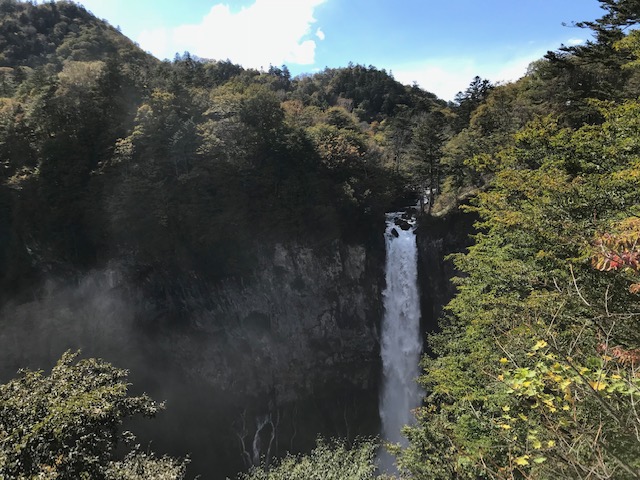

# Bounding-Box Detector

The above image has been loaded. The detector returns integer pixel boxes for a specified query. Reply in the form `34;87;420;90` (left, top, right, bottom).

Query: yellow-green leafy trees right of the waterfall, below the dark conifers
400;90;640;479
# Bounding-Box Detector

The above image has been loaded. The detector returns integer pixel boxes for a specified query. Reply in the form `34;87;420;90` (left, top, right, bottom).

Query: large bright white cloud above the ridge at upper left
136;0;326;68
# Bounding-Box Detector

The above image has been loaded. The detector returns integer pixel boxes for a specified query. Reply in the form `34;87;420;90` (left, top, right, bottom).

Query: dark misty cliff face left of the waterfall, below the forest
0;241;384;478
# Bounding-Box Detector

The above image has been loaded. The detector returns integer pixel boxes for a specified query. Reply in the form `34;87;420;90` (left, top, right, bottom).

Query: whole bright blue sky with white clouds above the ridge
67;0;602;100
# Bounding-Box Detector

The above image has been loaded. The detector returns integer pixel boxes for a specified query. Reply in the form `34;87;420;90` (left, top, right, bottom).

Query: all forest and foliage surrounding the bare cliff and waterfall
0;0;640;480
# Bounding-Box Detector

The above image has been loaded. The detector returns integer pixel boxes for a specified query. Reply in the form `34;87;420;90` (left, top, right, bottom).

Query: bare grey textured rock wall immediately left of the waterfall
164;242;381;403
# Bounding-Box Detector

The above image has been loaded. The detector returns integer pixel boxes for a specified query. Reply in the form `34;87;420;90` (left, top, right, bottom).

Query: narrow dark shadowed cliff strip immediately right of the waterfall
417;212;476;340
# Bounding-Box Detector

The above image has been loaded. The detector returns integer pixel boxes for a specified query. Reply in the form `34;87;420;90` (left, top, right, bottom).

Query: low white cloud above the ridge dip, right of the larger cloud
391;50;546;100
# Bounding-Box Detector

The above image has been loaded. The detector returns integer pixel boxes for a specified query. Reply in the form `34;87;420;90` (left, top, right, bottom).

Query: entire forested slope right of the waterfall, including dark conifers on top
399;0;640;480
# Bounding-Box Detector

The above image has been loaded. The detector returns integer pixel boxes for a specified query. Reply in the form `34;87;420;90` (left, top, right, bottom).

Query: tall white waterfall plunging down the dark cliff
379;213;422;473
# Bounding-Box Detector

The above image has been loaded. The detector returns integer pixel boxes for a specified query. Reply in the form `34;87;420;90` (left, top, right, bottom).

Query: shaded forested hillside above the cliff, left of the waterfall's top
0;0;448;304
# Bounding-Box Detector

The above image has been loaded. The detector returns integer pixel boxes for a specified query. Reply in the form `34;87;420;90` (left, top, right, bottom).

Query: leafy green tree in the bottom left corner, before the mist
0;352;185;480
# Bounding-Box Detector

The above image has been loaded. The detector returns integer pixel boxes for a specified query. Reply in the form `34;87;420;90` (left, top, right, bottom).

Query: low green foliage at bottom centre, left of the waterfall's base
239;439;379;480
